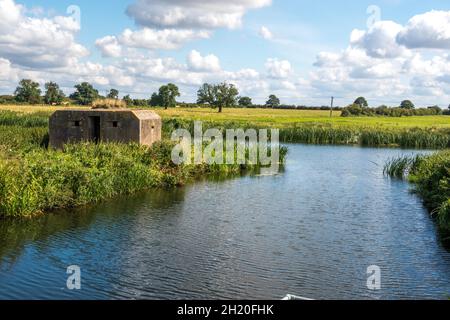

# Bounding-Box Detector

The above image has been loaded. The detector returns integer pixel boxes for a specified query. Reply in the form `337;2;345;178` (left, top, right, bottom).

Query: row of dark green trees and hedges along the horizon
0;79;450;117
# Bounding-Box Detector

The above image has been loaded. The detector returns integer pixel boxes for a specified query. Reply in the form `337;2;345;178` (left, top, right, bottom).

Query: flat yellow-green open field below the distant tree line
0;105;450;129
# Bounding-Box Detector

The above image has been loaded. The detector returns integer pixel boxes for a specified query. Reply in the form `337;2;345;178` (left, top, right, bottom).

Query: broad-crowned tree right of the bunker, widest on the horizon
197;82;239;112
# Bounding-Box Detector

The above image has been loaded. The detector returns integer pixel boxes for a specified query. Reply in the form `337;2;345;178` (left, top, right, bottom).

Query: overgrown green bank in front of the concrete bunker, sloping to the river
0;111;286;217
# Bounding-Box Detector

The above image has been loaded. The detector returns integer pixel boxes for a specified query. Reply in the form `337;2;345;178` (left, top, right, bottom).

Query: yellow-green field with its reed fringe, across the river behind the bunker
0;106;450;149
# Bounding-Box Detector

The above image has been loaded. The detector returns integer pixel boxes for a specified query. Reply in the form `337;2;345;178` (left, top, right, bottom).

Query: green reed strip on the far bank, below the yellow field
0;111;450;149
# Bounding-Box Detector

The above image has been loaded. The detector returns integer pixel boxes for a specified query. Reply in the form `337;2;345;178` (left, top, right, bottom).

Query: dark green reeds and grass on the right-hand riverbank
384;150;450;232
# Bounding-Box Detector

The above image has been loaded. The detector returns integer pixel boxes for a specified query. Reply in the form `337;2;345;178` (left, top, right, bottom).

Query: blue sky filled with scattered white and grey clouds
0;0;450;107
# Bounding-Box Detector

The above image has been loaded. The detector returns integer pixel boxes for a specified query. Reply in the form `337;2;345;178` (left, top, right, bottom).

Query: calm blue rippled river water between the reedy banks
0;145;450;299
